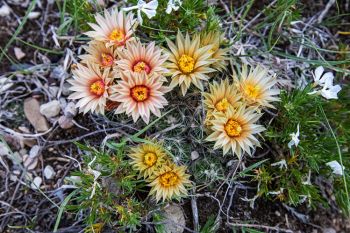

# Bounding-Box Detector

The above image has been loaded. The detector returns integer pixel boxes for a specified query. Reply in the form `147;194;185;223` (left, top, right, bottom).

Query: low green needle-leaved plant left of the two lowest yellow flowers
63;144;144;231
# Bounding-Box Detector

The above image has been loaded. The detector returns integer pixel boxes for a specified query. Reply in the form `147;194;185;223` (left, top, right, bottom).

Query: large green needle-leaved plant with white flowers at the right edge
255;86;350;214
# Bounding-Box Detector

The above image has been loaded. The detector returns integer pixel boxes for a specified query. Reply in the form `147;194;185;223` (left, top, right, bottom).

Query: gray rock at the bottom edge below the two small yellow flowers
163;204;186;233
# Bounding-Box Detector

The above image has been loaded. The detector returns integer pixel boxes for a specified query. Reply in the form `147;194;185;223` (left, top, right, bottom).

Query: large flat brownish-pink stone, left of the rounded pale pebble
24;98;49;132
